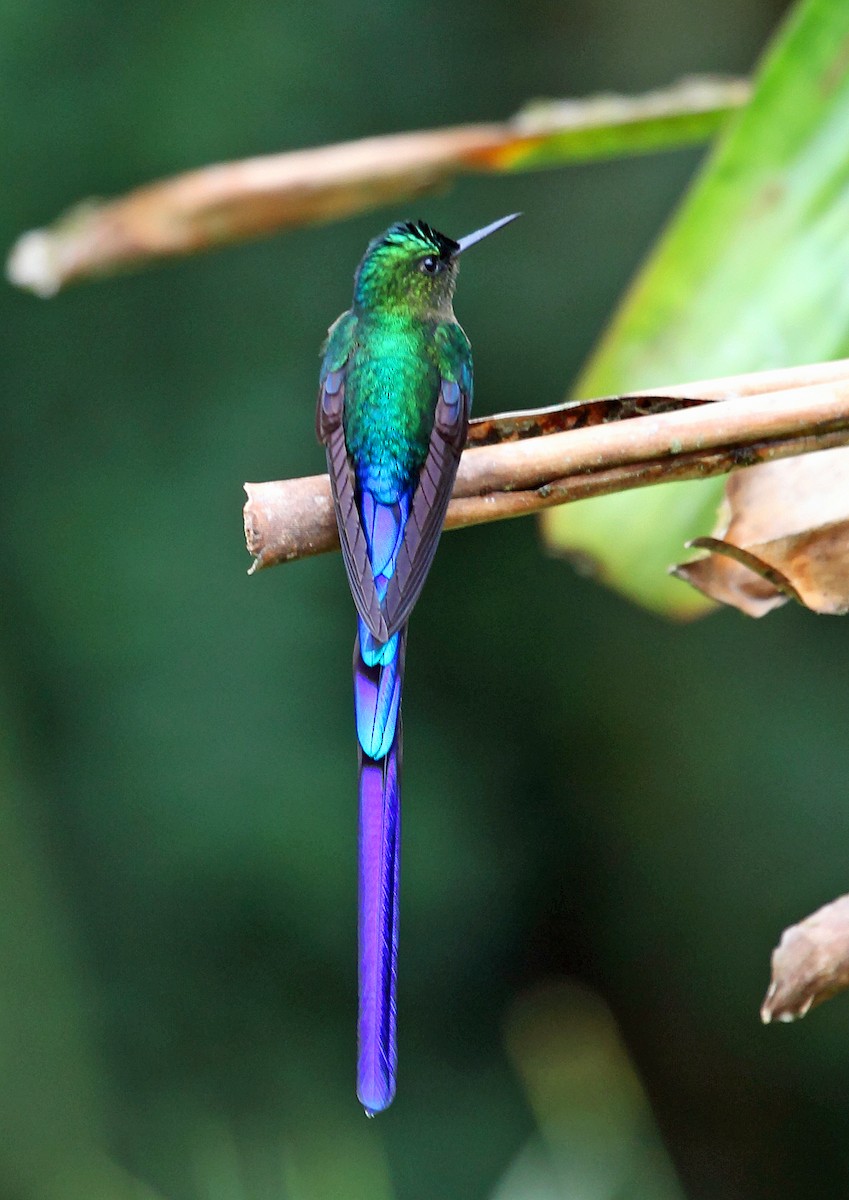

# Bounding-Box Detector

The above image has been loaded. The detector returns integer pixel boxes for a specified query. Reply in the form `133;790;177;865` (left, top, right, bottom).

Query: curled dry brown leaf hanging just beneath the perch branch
675;448;849;617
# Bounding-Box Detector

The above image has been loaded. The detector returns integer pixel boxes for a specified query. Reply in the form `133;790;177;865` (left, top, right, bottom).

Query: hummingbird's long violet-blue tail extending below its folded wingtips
354;622;407;1116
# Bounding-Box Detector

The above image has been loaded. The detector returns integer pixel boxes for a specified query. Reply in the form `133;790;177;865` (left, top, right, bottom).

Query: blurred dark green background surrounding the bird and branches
6;0;849;1200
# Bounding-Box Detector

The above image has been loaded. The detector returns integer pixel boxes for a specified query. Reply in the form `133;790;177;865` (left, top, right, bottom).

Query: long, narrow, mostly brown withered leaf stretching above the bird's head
6;77;749;296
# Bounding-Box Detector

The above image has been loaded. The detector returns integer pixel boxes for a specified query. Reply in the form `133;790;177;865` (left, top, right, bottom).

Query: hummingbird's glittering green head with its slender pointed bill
354;212;518;319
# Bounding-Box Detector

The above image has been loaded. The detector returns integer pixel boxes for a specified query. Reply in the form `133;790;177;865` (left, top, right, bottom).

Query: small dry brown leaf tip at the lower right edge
760;895;849;1025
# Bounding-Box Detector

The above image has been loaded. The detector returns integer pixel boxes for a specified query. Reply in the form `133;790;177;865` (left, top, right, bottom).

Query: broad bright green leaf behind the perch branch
543;0;849;617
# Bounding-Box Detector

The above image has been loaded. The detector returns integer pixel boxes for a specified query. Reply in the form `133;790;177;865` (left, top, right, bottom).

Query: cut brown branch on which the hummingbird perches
245;360;849;570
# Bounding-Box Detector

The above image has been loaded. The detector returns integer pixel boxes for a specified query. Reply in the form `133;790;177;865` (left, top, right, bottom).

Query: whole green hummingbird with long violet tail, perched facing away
315;212;519;1116
